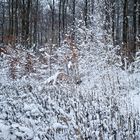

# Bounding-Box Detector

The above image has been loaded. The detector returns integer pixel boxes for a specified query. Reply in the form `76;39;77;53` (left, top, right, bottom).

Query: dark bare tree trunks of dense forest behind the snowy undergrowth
0;0;140;65
